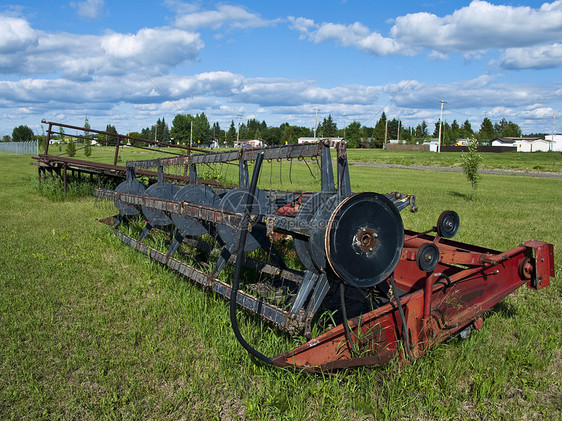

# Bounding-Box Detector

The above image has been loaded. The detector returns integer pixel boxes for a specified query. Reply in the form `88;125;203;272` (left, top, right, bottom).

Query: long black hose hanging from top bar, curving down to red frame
230;152;273;364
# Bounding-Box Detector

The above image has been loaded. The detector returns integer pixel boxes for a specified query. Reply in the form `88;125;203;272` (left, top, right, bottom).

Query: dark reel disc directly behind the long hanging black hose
217;189;270;251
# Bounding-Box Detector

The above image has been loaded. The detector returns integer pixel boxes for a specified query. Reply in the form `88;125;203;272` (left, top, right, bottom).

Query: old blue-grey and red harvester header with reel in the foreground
77;125;554;371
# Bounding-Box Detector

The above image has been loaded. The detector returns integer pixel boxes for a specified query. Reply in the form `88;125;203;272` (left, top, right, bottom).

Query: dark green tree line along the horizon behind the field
1;112;532;148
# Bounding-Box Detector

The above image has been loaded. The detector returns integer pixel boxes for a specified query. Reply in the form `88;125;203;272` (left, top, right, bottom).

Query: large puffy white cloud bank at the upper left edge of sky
0;16;203;80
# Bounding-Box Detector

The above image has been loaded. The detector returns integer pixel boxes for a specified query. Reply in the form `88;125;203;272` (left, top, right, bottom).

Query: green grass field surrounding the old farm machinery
0;148;562;420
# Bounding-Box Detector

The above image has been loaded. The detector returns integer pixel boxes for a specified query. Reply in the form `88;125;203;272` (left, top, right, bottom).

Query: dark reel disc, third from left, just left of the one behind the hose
172;184;219;236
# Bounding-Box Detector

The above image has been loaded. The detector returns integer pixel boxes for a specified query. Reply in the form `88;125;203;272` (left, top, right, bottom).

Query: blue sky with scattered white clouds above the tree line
0;0;562;134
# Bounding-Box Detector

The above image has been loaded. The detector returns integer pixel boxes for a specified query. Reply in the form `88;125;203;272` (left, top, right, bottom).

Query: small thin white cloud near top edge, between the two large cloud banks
175;4;275;30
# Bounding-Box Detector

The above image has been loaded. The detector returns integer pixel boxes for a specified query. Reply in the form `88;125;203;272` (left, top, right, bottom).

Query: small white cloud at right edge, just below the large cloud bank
499;43;562;70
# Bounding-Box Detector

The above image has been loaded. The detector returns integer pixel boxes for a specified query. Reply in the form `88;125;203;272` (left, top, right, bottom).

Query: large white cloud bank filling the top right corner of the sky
289;0;562;66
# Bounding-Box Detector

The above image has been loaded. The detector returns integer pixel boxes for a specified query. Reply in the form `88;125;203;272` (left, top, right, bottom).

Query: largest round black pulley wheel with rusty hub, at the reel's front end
325;192;404;288
